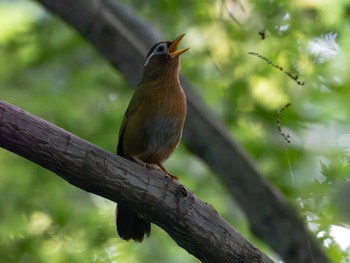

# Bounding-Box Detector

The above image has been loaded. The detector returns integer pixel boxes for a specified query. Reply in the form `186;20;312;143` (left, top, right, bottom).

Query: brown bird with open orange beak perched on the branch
116;34;189;242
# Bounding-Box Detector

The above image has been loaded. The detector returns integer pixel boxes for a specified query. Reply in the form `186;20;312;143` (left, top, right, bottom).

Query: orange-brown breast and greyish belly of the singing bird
124;84;186;163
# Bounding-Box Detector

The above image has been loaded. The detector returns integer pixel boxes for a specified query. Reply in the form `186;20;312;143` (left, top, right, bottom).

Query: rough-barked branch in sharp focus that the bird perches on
0;101;273;262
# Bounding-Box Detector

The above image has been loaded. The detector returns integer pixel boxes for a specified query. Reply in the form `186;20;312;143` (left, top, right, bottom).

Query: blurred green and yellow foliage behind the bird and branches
0;0;350;263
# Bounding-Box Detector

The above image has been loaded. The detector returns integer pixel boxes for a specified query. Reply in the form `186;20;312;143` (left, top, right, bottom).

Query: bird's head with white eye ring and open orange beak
142;34;189;81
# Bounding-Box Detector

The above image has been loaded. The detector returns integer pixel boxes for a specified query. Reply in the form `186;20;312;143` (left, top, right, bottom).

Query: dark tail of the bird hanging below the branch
115;204;151;242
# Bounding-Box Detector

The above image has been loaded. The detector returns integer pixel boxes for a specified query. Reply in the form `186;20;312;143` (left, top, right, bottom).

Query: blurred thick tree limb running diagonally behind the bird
16;0;329;263
